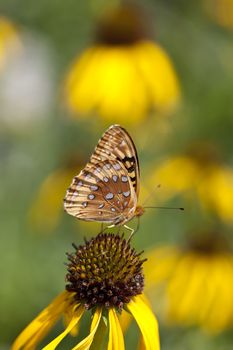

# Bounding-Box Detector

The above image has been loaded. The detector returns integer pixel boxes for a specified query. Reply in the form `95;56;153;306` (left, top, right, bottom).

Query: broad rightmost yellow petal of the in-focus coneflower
127;295;160;350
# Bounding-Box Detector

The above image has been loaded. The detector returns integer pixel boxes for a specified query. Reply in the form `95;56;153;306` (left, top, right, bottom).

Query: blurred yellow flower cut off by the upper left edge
0;17;20;71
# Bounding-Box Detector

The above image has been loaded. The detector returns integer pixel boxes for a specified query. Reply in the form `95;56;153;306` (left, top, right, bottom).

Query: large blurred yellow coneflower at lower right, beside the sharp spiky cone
144;232;233;333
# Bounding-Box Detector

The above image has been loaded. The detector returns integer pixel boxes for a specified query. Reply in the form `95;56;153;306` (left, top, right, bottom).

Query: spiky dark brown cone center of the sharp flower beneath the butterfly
66;234;146;310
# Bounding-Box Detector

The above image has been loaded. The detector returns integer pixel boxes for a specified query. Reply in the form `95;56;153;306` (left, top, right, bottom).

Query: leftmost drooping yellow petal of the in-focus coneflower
12;291;70;350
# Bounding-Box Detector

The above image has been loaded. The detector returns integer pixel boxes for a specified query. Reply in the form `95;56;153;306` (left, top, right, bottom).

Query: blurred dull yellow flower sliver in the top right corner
204;0;233;29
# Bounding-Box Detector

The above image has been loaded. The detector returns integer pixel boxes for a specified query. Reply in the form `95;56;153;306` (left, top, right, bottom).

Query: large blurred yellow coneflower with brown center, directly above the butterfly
65;7;179;123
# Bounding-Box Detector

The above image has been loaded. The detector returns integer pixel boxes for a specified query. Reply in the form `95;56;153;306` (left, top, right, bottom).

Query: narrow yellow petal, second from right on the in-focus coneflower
108;309;125;350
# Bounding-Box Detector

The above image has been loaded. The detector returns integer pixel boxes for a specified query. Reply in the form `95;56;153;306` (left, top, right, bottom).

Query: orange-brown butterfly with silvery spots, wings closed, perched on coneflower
64;125;144;230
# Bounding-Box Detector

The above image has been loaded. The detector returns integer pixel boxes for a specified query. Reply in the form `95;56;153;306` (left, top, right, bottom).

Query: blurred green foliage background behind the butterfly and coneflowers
0;0;233;350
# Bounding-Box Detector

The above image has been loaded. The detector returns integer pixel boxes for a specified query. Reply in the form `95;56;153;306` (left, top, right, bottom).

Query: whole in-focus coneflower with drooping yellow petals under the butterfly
12;234;160;350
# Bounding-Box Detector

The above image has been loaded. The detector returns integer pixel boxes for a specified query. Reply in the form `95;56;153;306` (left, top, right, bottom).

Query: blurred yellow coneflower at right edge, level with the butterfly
150;144;233;222
